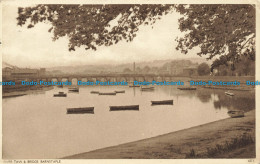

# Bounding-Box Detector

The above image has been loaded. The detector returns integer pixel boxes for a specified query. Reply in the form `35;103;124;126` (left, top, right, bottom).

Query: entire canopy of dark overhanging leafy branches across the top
17;4;256;67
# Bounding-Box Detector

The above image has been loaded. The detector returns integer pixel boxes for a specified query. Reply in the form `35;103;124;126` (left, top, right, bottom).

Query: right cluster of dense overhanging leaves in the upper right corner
176;4;255;64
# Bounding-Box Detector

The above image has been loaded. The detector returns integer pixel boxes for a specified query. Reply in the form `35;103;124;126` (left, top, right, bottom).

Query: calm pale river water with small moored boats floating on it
2;86;255;158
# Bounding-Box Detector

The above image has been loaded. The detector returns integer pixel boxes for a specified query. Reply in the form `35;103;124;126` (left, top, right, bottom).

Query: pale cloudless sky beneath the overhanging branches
2;4;206;68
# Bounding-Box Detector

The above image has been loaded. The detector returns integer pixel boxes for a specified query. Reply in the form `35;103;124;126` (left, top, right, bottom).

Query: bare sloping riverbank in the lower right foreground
65;110;255;159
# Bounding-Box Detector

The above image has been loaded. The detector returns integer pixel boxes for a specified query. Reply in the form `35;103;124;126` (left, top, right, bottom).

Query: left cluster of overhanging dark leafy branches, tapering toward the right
17;5;172;51
